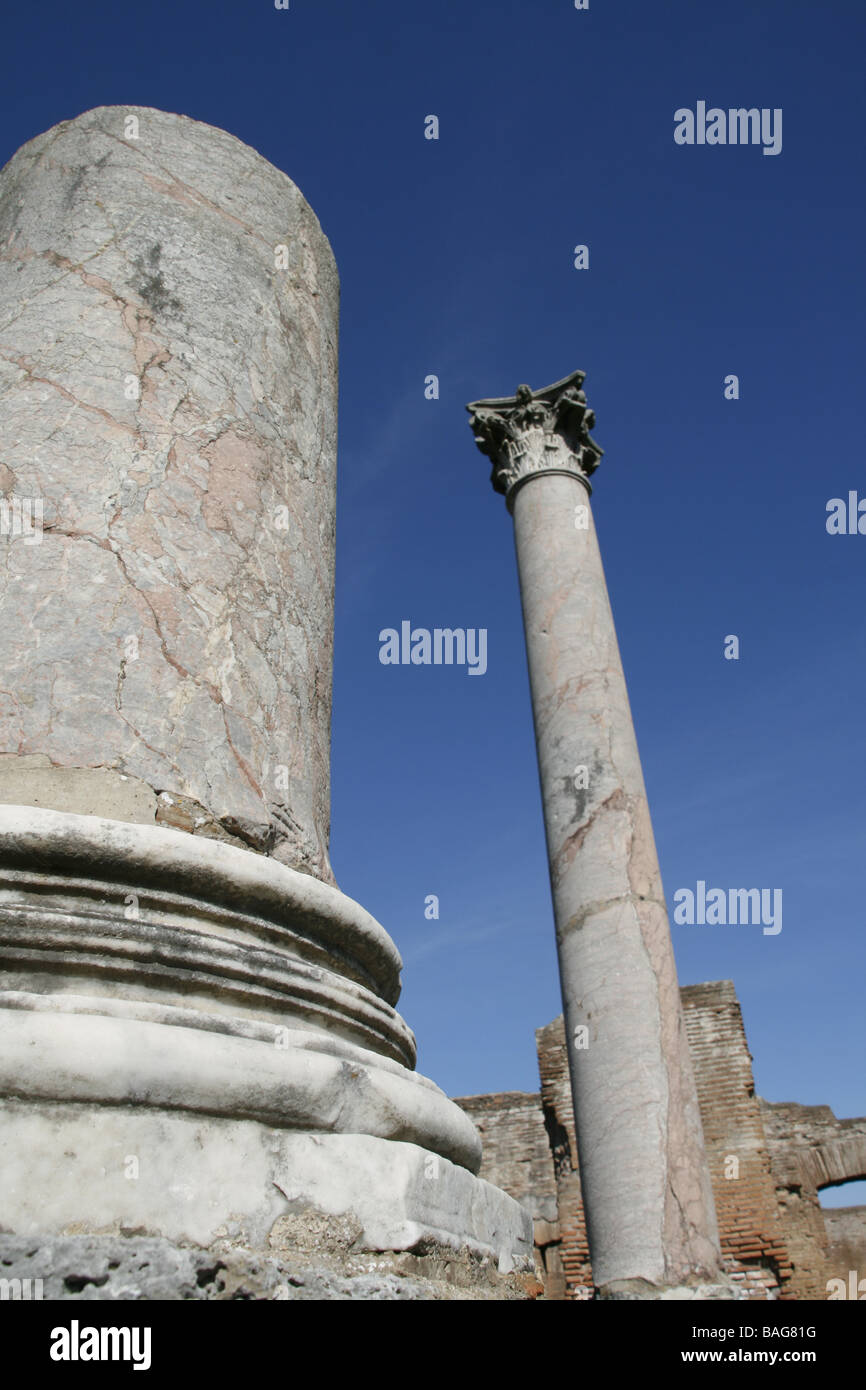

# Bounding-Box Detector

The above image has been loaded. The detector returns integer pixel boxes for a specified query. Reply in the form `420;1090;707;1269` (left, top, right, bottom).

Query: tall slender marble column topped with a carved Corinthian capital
467;371;720;1297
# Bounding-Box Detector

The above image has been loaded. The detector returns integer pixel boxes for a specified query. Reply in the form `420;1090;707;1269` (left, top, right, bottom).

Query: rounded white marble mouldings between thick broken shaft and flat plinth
0;806;481;1172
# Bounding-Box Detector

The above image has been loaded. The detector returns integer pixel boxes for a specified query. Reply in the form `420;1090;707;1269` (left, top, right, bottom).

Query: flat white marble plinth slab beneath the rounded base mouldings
0;1099;532;1273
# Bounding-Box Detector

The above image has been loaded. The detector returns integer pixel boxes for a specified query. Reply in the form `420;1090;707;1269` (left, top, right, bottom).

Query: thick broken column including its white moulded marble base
0;107;531;1268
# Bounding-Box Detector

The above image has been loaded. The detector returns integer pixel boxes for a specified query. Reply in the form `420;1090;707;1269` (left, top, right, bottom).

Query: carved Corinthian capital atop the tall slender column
466;371;603;509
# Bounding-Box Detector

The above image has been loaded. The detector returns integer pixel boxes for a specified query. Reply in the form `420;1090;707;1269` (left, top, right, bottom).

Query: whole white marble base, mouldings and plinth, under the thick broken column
0;806;534;1297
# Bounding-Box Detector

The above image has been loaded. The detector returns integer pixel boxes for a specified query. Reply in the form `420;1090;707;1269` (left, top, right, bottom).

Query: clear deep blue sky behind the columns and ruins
0;0;866;1201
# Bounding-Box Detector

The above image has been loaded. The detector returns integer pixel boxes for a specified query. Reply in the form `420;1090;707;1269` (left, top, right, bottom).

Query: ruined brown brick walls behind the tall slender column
457;980;866;1300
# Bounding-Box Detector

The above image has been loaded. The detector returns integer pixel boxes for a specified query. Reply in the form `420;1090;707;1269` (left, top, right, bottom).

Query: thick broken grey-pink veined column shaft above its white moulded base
0;107;338;881
